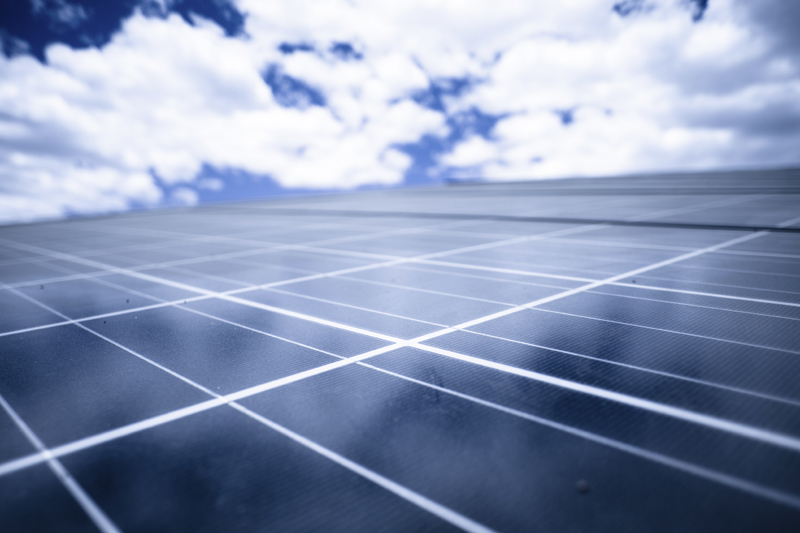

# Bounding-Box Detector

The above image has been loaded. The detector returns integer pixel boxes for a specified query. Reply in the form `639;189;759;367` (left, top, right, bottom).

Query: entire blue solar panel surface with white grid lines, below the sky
0;171;800;531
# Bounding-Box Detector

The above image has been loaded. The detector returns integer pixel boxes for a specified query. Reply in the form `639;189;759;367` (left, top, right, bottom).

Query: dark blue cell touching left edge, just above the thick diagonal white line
0;322;208;445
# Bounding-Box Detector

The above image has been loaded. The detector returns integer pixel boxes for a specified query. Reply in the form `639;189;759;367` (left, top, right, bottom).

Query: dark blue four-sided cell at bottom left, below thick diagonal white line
63;407;460;532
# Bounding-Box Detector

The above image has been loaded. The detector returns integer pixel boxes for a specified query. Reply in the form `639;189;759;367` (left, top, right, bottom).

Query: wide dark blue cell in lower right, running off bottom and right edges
242;366;800;531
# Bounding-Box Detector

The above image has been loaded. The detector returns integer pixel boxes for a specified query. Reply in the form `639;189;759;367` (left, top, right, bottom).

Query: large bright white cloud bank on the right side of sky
442;1;800;179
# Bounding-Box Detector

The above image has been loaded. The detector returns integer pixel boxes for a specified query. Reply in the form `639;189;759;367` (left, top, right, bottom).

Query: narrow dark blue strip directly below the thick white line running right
365;348;800;494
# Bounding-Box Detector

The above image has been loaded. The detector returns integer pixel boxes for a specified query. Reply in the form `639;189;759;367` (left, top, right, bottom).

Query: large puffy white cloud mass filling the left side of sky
0;9;443;220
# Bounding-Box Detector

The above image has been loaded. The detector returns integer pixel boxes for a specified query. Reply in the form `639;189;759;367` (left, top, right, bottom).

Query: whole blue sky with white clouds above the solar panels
0;0;800;224
